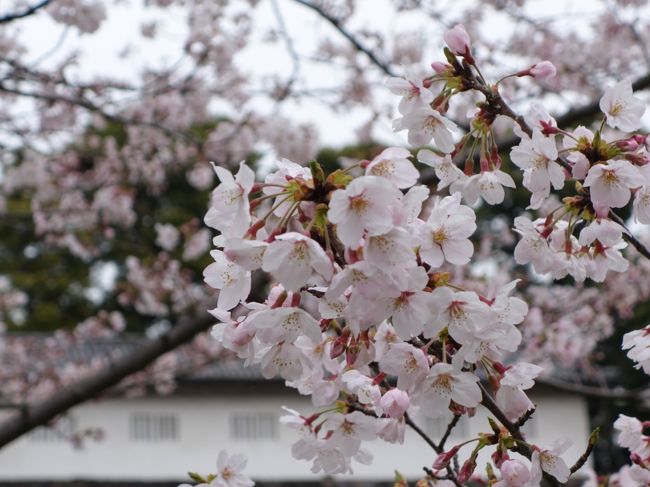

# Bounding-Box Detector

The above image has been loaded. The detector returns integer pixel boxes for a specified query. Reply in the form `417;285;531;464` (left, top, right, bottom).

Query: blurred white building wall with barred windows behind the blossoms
0;384;589;482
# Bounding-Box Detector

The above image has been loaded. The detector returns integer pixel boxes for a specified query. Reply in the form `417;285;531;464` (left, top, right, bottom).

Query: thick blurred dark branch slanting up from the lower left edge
0;316;213;447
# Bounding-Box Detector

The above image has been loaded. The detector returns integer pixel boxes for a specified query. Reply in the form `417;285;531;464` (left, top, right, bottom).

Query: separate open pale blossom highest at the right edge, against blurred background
599;79;645;132
